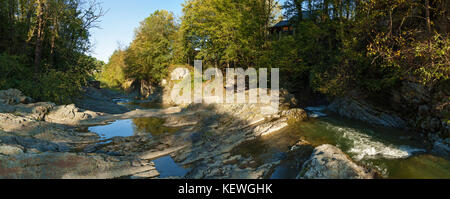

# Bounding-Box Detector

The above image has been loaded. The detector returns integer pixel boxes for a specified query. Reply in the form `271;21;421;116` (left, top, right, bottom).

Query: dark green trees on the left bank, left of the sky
0;0;103;103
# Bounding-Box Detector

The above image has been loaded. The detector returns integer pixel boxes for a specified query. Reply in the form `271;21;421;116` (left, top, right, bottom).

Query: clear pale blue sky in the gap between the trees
91;0;284;62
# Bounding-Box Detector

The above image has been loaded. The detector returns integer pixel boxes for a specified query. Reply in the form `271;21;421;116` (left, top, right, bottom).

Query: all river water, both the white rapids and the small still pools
85;103;450;179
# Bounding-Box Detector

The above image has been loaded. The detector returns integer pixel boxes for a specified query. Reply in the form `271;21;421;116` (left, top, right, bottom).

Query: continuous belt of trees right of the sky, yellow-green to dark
101;0;450;109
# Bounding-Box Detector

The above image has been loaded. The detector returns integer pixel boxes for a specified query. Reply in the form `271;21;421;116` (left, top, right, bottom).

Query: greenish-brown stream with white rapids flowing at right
272;112;450;179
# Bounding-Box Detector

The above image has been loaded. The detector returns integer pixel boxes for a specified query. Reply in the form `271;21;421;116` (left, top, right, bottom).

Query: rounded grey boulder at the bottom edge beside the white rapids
297;145;374;179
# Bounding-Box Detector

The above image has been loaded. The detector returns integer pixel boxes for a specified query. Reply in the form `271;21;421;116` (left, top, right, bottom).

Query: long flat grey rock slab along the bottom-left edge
0;152;155;179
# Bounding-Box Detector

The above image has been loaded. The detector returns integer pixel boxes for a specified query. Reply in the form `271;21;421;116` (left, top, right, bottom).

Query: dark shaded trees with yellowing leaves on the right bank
272;0;450;101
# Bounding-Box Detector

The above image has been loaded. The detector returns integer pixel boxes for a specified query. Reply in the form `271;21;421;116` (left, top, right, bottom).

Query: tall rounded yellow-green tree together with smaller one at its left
100;10;178;88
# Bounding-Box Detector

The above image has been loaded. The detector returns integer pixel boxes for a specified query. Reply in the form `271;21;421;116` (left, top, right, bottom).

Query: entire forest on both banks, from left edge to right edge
0;0;450;103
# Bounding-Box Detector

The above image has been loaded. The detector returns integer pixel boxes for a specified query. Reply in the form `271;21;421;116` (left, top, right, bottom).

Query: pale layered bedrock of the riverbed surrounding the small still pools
0;88;380;179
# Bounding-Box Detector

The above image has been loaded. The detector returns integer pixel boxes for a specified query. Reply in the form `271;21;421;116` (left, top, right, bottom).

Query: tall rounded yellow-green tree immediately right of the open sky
125;10;177;83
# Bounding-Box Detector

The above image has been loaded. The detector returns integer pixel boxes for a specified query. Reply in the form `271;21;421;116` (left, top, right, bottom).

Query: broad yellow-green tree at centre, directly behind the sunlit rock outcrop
181;0;279;67
